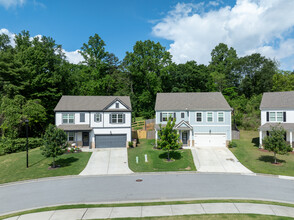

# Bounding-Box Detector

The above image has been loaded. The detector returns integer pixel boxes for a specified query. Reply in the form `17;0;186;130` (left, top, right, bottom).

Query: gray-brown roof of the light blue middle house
155;92;232;111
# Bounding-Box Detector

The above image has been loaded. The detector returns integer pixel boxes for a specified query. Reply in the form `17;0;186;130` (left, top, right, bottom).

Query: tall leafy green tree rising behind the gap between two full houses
123;40;171;118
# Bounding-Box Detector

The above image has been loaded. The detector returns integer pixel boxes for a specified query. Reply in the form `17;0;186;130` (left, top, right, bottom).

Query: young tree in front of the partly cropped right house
263;127;292;164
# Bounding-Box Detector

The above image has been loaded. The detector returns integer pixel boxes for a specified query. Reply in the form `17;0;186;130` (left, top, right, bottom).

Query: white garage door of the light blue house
195;134;227;147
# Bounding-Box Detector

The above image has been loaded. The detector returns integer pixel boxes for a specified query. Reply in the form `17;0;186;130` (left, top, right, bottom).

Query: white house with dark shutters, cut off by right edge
259;91;294;147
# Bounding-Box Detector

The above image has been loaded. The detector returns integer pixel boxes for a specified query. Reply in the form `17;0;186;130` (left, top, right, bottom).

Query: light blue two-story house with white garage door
155;92;232;148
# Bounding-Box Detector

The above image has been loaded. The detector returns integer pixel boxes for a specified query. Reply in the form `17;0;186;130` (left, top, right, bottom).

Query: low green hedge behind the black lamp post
0;138;43;155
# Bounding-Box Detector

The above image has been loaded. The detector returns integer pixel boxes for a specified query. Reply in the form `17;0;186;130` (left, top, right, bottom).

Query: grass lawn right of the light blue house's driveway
230;131;294;176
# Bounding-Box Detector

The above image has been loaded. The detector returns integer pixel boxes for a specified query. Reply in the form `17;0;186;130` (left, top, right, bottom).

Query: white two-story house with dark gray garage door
54;96;132;148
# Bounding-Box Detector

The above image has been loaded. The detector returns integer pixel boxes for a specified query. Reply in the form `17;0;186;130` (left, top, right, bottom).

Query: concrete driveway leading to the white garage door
191;147;252;173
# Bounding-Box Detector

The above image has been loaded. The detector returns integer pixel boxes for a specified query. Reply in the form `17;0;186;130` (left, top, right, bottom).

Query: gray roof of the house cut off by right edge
260;91;294;110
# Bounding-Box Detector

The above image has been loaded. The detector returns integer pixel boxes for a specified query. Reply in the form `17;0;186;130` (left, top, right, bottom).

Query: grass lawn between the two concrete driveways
128;139;196;172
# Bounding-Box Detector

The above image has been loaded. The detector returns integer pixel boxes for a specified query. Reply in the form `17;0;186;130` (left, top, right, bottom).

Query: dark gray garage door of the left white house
95;134;127;148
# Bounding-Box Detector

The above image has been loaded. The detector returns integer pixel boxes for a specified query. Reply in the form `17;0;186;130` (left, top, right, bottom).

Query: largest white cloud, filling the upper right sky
153;0;294;69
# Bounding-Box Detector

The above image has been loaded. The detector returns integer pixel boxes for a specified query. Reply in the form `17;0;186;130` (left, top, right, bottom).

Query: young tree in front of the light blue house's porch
157;118;181;161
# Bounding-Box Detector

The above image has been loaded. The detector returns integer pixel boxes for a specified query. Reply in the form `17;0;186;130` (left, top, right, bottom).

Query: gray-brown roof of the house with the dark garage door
54;96;132;112
